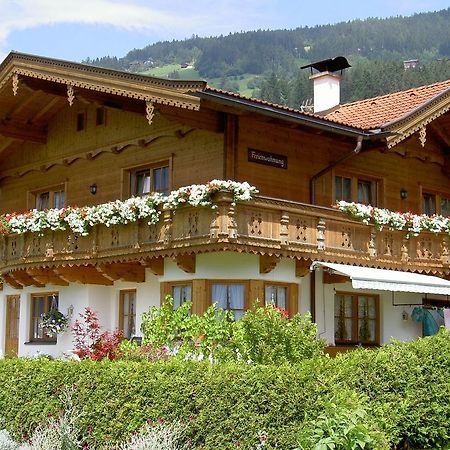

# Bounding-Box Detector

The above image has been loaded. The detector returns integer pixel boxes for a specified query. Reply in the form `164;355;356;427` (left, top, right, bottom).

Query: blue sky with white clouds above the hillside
0;0;450;61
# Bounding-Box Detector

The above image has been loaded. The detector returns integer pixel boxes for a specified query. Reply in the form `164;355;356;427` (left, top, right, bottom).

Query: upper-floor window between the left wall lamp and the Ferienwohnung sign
129;162;169;196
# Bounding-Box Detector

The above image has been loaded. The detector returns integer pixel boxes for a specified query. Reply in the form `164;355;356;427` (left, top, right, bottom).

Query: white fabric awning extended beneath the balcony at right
311;261;450;295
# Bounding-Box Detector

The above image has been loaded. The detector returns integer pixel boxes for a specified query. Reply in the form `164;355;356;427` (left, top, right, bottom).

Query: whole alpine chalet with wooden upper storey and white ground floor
0;53;450;355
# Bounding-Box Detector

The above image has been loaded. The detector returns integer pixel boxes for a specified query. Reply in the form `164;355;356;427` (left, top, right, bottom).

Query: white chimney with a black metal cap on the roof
301;56;351;113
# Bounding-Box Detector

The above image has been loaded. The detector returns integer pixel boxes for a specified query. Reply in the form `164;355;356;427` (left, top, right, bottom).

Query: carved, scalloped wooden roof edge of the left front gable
0;52;206;110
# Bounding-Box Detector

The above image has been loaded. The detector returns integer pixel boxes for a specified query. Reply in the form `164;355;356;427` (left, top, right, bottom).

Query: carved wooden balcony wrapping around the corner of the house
0;192;450;287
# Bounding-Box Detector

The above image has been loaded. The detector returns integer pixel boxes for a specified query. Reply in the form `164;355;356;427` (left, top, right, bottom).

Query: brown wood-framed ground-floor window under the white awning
334;293;379;345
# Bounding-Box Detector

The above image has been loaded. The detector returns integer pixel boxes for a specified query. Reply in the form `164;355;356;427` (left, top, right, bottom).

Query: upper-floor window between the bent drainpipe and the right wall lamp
334;175;377;205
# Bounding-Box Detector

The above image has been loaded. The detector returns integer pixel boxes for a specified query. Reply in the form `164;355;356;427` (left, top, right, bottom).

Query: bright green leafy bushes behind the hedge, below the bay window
141;296;325;364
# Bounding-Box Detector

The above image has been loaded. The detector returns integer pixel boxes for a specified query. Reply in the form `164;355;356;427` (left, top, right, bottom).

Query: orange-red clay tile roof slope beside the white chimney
205;80;450;130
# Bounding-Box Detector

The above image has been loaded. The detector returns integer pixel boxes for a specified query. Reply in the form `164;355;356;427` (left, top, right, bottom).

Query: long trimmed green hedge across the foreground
0;331;450;450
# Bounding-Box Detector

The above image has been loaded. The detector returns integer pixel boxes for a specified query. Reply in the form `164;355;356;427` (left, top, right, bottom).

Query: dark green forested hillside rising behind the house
84;8;450;107
